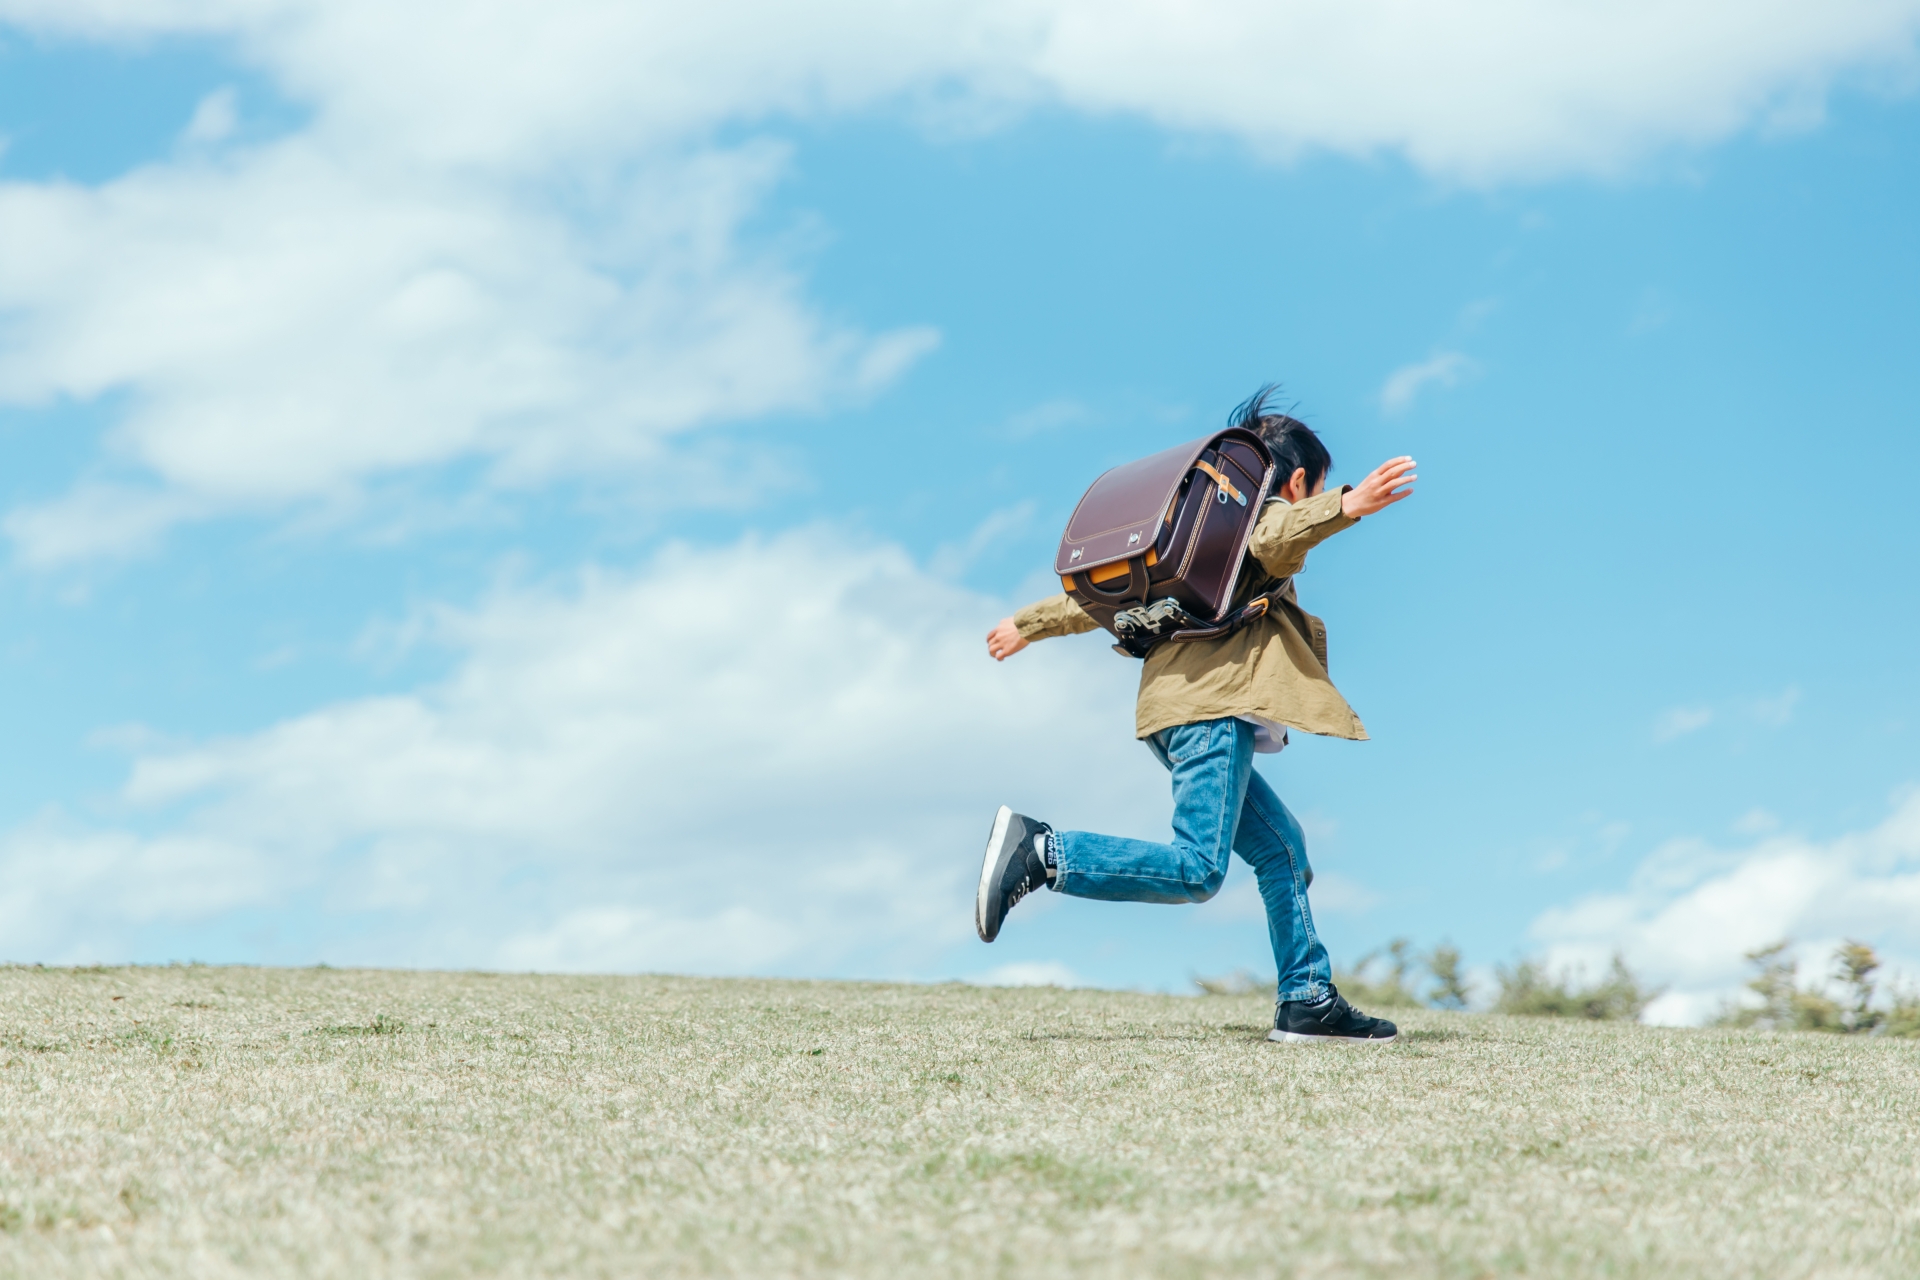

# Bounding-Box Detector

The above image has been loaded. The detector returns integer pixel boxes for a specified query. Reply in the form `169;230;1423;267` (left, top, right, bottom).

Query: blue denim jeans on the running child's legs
1052;720;1332;1000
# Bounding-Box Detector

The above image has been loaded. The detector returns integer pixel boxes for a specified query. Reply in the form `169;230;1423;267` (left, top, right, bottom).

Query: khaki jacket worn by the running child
1014;487;1367;739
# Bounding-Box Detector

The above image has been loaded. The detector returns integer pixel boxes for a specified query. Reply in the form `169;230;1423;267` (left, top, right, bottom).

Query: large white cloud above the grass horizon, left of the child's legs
0;530;1165;973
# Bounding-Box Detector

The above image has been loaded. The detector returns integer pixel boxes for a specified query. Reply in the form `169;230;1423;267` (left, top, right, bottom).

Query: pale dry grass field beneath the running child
0;967;1920;1278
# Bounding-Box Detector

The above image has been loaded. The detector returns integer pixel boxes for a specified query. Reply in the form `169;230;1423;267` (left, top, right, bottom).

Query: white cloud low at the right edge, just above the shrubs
1530;791;1920;1023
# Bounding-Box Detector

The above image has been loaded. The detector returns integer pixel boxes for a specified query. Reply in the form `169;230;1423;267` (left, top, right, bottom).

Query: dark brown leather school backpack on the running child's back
1054;428;1275;658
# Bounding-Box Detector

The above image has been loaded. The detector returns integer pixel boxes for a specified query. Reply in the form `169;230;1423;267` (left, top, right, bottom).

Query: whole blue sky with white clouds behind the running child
0;0;1920;1019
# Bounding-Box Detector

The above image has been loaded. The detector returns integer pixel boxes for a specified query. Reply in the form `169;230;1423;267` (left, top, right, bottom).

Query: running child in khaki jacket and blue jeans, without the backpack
973;388;1415;1044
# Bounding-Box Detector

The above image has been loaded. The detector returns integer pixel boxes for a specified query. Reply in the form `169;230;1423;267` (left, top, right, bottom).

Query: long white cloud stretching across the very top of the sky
22;0;1896;180
